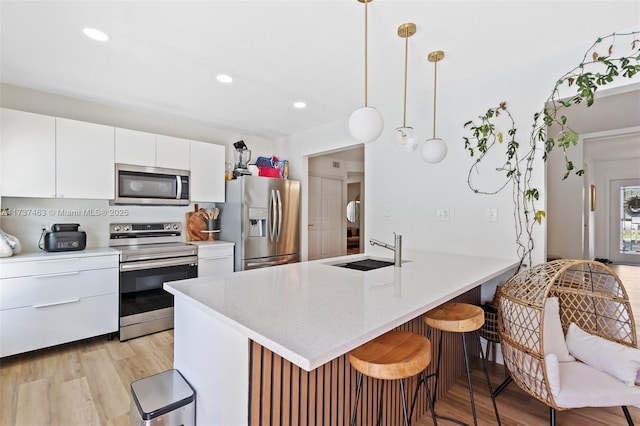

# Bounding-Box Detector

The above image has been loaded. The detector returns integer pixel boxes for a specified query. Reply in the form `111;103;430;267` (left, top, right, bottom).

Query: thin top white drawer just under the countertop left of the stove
0;254;118;278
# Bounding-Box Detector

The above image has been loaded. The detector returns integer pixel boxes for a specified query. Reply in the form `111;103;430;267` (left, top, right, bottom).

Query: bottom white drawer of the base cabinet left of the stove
0;293;118;357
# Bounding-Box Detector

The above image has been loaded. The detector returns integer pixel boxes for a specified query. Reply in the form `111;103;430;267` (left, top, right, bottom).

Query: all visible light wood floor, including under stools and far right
0;266;640;426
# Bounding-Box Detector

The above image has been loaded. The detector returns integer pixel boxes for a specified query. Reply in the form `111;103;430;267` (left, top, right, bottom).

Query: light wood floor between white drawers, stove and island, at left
0;331;173;426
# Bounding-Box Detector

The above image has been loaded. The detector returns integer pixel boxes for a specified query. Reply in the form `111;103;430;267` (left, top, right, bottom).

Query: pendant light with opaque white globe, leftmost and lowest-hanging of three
349;0;384;143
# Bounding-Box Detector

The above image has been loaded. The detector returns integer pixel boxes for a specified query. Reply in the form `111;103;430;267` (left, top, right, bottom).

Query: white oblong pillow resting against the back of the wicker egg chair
567;323;640;386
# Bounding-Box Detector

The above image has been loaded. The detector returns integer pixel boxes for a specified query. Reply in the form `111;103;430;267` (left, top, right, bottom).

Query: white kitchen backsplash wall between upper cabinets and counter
0;197;215;253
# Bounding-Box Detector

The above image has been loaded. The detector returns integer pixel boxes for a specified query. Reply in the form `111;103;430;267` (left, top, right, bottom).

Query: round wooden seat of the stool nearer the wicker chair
424;302;484;333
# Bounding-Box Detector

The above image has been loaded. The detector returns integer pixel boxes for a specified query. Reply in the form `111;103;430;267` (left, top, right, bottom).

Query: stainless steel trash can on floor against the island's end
129;370;196;426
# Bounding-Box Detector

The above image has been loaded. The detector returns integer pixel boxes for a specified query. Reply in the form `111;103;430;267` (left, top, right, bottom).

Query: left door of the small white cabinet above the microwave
115;127;156;166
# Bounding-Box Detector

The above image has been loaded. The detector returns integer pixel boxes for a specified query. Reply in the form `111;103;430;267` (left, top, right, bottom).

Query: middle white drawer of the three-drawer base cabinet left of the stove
0;265;118;310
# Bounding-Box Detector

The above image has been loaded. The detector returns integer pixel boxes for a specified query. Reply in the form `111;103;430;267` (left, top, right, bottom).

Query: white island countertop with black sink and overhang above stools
165;251;518;371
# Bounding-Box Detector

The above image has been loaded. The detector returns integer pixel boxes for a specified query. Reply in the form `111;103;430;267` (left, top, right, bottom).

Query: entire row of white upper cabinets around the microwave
0;108;226;203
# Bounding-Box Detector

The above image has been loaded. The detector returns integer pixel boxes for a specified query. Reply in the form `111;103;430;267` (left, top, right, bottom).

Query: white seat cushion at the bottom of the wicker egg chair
554;361;640;408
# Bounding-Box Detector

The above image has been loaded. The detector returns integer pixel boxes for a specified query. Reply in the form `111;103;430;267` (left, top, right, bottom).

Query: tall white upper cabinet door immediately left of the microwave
56;118;115;200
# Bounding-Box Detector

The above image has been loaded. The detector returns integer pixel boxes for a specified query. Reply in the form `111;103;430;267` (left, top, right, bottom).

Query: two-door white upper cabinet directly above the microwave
115;128;190;170
